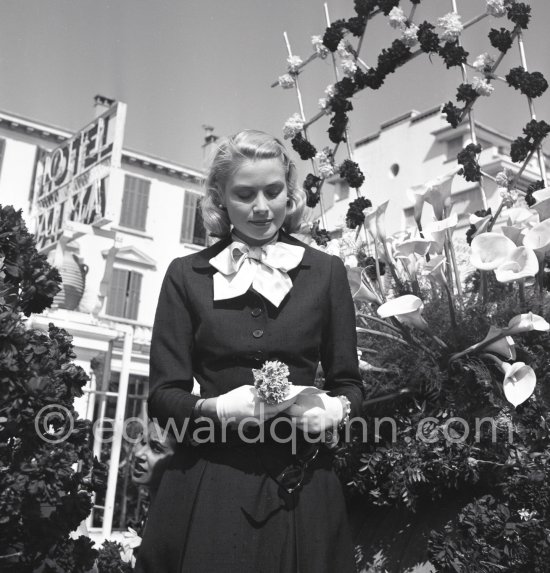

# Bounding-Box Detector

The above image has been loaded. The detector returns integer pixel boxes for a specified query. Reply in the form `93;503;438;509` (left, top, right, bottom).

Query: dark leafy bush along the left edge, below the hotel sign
0;207;105;573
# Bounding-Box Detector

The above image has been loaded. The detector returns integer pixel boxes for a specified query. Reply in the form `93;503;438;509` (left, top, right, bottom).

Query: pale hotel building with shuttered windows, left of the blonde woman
0;98;206;537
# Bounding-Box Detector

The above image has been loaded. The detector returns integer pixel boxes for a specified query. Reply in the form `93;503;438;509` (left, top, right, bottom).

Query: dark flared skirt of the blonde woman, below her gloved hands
136;438;356;573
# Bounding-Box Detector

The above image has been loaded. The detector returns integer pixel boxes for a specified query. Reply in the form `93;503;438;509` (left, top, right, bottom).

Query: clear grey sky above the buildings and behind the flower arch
0;0;550;169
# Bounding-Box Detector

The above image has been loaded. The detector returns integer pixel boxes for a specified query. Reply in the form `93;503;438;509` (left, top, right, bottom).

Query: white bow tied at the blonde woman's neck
209;241;304;307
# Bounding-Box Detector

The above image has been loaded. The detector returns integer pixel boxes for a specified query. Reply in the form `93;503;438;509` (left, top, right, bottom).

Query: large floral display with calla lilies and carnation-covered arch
273;0;550;573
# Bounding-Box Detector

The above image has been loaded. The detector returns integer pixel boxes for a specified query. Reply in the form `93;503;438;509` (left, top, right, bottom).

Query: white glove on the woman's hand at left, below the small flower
216;385;296;424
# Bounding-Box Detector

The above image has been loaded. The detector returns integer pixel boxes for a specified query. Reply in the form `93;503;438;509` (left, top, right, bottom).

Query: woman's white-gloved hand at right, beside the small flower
285;388;344;434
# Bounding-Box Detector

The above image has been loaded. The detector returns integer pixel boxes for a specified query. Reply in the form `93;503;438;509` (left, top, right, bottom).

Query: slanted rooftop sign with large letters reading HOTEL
33;102;126;252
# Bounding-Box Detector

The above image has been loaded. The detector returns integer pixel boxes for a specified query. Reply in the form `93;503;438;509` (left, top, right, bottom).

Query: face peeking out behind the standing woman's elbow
132;422;175;487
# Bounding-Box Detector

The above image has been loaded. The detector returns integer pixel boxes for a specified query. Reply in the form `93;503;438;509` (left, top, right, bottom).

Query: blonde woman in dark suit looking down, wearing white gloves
137;131;362;573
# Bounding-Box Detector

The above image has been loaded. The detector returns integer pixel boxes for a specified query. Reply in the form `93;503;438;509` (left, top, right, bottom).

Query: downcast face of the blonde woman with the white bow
223;158;288;245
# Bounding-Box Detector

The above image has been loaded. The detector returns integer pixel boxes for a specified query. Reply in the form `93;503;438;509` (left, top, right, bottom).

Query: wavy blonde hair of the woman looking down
201;129;306;237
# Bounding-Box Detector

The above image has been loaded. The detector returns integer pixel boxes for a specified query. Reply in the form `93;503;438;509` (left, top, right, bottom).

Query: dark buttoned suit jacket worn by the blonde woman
149;231;363;428
